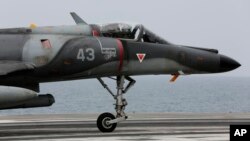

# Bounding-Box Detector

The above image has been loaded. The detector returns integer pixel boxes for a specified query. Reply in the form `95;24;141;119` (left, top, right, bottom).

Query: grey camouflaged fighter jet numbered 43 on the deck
0;12;240;132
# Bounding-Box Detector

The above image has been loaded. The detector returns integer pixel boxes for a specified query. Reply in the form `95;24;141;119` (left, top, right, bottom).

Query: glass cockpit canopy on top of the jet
92;23;171;44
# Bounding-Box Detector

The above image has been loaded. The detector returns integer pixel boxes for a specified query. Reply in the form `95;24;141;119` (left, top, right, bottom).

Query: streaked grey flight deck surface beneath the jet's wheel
0;113;250;141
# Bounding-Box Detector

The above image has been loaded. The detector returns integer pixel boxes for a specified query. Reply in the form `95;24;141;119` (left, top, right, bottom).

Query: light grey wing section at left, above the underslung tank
0;60;35;75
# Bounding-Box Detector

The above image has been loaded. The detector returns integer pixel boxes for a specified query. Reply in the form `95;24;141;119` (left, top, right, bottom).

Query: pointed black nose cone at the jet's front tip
219;55;241;72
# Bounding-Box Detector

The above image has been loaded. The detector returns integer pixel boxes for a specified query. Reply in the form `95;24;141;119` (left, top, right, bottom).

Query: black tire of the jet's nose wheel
96;113;117;132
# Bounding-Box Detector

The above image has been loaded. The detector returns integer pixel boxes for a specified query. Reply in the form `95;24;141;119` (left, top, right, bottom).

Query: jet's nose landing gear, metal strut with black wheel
97;75;135;132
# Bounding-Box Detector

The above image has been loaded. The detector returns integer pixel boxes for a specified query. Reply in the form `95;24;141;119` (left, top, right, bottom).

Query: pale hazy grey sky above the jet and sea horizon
0;0;250;76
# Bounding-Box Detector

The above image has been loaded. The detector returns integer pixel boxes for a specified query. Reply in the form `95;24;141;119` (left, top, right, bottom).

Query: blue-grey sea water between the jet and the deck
0;75;250;115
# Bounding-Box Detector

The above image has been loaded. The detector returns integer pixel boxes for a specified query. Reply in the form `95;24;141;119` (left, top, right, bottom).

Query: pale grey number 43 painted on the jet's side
76;48;95;61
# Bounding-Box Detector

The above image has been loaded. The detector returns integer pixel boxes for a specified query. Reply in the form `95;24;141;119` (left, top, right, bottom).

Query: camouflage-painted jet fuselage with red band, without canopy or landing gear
0;25;237;91
